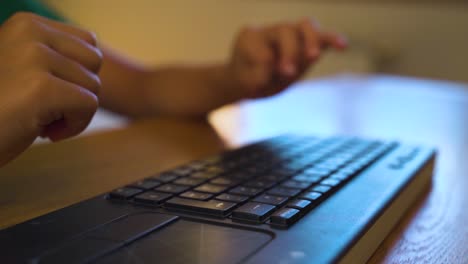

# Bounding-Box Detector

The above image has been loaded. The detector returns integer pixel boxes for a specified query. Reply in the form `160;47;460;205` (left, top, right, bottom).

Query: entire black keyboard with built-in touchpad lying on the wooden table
0;135;436;264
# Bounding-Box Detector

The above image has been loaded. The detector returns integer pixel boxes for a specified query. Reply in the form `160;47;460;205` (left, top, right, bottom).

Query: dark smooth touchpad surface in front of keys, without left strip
97;220;272;264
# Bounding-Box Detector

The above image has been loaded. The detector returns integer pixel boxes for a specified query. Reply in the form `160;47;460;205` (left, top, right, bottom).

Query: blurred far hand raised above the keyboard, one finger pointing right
229;19;347;98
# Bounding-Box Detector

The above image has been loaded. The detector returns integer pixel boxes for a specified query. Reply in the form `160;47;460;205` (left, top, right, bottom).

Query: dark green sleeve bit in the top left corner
0;0;65;24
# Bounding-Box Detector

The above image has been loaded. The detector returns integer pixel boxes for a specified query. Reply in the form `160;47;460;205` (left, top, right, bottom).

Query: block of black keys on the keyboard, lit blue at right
107;136;396;228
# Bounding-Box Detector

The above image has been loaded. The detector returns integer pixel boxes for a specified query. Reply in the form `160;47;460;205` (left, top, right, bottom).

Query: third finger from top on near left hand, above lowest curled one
39;45;101;95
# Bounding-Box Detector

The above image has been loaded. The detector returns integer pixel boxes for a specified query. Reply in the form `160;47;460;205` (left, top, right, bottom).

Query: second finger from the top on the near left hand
45;24;102;73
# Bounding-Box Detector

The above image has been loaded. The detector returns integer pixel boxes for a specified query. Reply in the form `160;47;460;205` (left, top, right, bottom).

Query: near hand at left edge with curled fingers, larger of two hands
0;13;102;166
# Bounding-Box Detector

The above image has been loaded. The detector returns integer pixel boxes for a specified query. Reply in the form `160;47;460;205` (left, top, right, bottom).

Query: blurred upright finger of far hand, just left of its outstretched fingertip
298;19;321;61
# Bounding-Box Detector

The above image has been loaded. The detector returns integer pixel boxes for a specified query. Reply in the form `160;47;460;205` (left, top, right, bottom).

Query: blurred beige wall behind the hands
46;0;468;82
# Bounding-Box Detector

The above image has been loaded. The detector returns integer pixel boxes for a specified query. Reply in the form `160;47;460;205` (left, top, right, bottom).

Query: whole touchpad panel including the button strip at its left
39;212;272;264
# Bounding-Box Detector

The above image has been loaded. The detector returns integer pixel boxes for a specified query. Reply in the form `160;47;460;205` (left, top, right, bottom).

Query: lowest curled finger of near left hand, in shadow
40;76;98;141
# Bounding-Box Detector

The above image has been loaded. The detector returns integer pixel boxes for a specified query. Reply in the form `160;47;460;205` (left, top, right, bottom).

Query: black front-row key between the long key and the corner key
232;202;276;223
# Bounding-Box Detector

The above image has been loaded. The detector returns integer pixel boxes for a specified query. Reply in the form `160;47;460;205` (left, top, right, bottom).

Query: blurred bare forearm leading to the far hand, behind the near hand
100;48;241;118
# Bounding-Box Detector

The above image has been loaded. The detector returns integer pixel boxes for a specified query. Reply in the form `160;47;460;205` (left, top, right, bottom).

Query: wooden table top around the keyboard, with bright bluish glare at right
0;76;468;263
